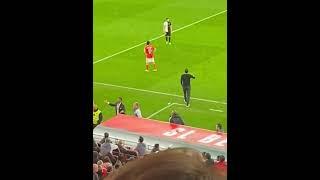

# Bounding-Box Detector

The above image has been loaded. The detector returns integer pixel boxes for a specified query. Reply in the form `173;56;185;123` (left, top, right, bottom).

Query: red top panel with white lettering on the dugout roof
101;115;227;151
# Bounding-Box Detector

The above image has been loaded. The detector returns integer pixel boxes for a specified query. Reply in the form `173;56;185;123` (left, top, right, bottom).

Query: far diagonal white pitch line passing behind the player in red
93;10;227;64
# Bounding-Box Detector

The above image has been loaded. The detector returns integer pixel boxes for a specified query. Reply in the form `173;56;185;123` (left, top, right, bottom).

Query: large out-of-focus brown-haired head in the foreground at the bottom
107;148;214;180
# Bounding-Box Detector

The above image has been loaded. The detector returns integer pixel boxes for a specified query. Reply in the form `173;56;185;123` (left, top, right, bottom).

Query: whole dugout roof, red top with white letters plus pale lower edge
93;115;227;158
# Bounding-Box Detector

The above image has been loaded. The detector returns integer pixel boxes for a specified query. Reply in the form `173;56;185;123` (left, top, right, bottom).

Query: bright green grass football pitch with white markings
93;0;227;130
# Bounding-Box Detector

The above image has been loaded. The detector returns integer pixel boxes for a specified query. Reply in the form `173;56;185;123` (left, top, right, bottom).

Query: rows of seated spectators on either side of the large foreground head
93;133;227;180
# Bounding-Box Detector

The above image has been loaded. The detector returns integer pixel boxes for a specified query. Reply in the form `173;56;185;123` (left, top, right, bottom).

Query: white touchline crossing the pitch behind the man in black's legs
93;82;227;104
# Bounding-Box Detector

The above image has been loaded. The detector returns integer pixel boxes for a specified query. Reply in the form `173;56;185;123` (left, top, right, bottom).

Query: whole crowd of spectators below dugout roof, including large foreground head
93;133;227;180
